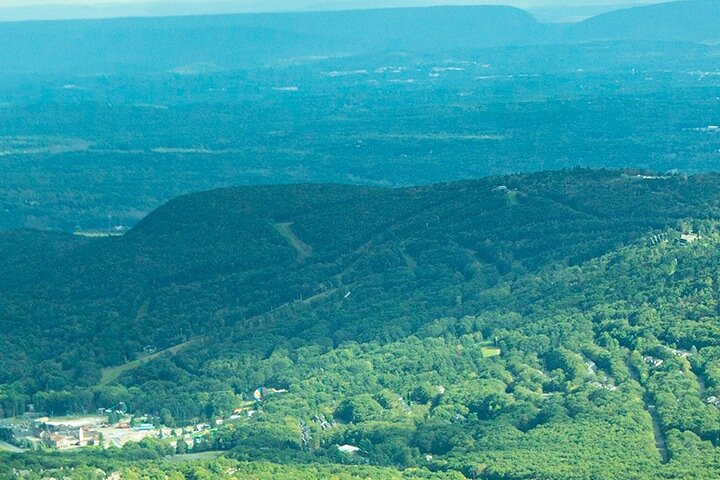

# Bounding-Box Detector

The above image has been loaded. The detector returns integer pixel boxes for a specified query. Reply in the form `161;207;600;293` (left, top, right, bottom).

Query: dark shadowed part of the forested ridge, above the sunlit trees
5;171;720;380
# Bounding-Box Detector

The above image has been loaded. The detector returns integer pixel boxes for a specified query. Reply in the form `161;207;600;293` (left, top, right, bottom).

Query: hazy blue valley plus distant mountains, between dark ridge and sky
0;1;720;231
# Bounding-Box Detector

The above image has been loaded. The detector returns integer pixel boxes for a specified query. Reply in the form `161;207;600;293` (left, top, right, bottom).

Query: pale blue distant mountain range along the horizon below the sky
0;0;720;74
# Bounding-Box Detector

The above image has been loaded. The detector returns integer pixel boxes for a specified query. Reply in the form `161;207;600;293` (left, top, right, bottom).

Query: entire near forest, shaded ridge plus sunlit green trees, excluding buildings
5;169;720;480
